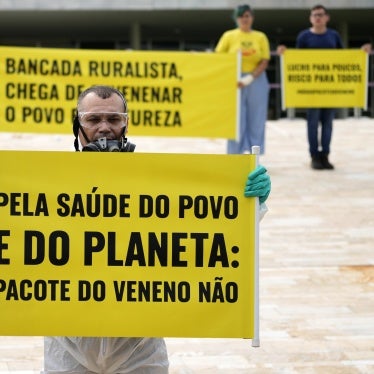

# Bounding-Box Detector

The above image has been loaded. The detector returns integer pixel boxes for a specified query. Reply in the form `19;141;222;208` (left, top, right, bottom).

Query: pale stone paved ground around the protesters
0;118;374;374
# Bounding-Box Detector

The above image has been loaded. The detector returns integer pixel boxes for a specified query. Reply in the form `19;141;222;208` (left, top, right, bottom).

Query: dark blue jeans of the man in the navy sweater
306;108;335;156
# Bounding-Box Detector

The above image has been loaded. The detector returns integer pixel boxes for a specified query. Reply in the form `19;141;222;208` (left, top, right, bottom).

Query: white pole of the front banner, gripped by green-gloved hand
251;146;260;347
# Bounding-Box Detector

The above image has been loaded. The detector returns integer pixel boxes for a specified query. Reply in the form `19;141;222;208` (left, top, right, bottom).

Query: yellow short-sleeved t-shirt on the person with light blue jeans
215;29;270;73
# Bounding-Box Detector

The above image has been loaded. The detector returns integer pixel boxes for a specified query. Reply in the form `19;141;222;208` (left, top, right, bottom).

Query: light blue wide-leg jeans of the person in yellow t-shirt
227;72;270;154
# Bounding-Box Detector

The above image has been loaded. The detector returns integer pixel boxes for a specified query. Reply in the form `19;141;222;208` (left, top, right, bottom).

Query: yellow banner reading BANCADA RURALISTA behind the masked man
0;47;237;139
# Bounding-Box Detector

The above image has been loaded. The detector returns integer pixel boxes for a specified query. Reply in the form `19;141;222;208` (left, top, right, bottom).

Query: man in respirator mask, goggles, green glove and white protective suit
42;86;271;374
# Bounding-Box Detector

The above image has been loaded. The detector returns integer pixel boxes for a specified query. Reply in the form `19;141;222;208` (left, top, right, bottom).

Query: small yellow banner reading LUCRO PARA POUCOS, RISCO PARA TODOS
281;49;368;109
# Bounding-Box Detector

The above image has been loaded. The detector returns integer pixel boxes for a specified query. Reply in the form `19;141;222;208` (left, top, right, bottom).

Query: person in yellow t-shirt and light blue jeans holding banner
215;5;270;154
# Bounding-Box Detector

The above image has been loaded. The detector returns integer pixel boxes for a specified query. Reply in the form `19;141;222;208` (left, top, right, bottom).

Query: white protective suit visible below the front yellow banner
42;337;169;374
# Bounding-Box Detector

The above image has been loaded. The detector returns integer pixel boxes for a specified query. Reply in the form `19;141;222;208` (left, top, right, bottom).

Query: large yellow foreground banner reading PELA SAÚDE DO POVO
0;151;257;338
